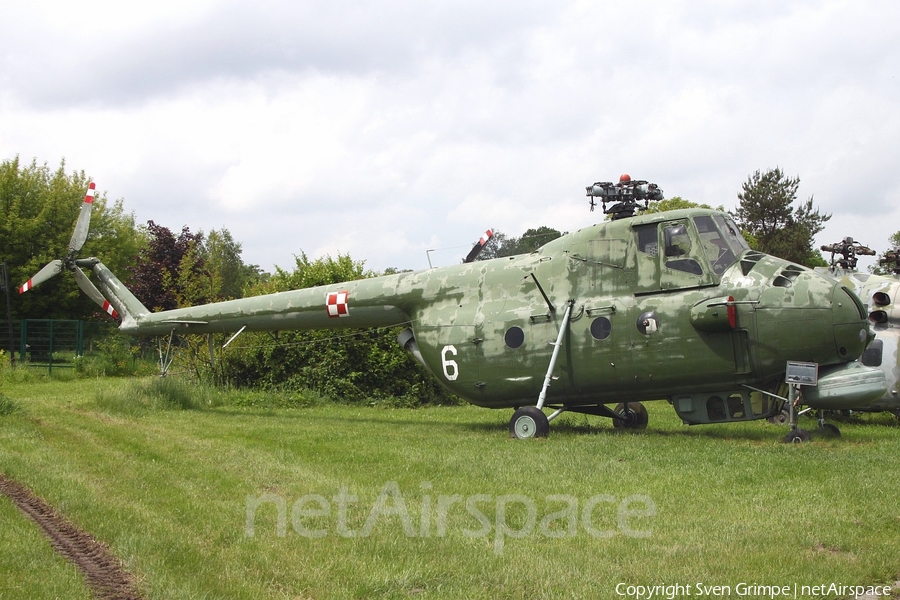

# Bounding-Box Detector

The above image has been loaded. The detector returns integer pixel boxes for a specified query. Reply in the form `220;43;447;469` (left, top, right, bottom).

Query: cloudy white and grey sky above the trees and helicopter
0;0;900;270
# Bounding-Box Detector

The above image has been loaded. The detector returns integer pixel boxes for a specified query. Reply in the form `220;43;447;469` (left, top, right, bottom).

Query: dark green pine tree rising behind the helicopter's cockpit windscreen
732;167;831;266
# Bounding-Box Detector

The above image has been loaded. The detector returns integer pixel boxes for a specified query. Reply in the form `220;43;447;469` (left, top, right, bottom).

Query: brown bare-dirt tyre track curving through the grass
0;473;143;600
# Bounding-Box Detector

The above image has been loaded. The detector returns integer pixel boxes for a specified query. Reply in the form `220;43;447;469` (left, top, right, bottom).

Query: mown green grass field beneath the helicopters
0;379;900;599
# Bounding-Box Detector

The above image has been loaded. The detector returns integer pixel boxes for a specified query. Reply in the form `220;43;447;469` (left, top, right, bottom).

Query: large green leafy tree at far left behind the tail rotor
0;157;144;319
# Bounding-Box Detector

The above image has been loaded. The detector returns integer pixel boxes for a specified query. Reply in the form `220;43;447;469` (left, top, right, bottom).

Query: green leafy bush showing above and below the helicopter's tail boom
214;254;452;405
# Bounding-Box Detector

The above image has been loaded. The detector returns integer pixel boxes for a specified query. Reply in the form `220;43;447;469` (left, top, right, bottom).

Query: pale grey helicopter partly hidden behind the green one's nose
816;237;900;418
